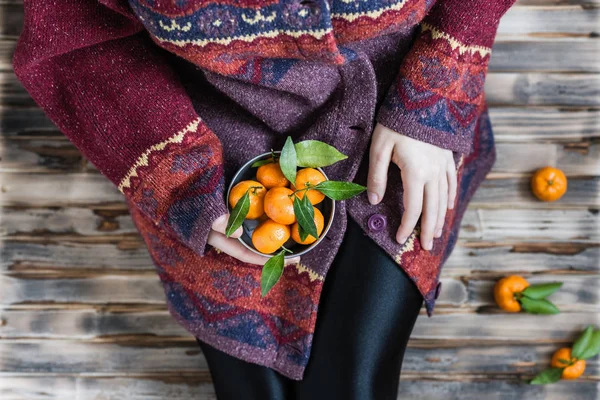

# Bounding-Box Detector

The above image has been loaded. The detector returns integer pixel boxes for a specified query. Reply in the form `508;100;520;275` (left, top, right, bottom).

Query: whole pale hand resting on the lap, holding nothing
367;124;456;250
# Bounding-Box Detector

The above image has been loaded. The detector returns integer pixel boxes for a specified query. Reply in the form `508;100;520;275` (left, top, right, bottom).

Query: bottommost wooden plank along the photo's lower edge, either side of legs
0;374;600;400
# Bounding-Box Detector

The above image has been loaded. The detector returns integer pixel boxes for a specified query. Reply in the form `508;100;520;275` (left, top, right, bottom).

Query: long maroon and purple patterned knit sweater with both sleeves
13;0;513;379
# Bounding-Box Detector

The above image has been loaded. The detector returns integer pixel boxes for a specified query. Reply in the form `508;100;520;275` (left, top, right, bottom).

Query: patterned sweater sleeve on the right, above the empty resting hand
376;0;515;154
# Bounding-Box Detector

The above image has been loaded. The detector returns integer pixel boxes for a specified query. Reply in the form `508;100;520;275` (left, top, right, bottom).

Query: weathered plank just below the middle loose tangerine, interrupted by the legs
0;306;600;343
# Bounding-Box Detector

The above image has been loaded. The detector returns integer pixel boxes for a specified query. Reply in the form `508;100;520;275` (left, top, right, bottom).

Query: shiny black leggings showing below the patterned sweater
198;218;423;400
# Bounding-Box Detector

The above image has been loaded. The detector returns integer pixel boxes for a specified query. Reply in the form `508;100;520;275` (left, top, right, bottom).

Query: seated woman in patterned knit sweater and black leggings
14;0;513;400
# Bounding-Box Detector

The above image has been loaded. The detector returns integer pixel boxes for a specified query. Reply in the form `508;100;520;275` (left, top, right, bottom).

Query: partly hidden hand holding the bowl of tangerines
208;214;300;265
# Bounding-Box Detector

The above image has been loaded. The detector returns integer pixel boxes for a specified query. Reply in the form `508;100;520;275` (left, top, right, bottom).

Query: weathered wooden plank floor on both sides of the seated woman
0;0;600;400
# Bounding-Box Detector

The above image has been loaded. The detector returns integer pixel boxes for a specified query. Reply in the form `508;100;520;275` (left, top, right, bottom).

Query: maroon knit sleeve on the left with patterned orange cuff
13;0;227;255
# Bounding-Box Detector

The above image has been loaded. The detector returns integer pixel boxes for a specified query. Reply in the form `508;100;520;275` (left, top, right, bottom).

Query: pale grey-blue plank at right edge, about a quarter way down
485;73;600;106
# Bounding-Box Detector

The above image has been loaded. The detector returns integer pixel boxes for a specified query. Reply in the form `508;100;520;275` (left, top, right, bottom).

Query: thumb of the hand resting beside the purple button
367;133;393;204
